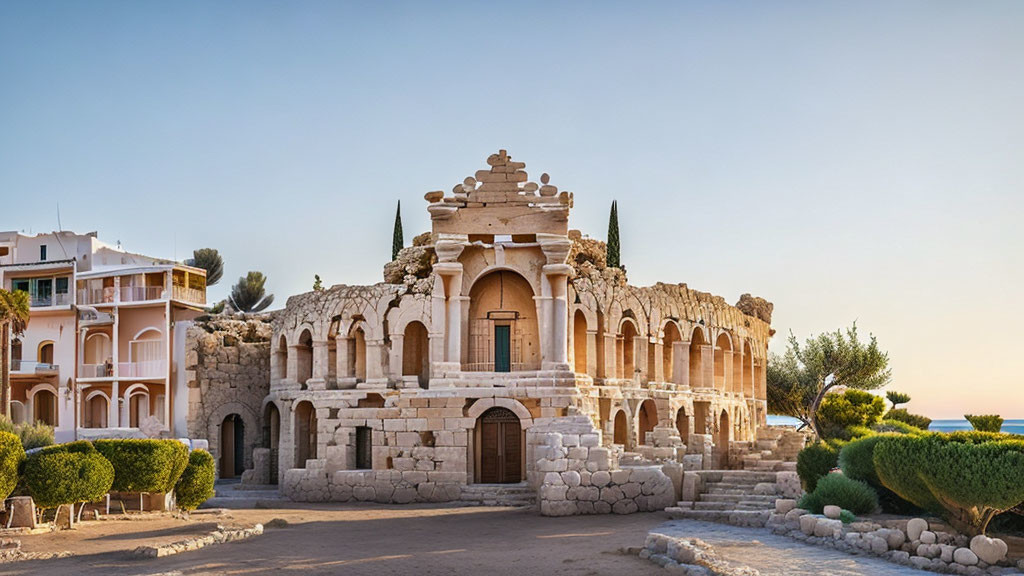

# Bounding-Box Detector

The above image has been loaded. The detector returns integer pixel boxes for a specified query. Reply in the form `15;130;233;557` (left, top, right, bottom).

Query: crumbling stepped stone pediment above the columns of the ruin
425;150;572;236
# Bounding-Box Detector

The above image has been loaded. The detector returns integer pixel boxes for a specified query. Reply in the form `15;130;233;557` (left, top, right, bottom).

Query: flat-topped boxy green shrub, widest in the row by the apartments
93;440;188;493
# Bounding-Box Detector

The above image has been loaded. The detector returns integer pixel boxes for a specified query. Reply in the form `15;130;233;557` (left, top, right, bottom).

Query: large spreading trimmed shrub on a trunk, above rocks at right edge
874;431;1024;535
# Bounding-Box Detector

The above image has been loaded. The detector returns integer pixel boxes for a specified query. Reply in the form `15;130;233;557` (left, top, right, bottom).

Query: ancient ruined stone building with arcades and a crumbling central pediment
257;151;771;515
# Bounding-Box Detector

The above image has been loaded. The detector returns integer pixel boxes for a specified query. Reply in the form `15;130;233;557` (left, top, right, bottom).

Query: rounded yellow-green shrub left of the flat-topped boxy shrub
25;443;114;508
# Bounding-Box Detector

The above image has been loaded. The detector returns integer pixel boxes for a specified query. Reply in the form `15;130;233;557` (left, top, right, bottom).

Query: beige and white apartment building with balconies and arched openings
0;232;206;442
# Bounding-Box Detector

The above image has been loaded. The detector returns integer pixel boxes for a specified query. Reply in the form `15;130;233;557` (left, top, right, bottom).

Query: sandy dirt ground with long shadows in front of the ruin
0;504;666;576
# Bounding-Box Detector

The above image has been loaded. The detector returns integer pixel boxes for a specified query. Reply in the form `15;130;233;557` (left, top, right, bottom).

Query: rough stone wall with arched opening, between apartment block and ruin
184;315;271;480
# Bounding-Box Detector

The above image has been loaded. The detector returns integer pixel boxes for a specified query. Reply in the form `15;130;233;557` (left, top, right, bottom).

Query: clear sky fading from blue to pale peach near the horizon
0;1;1024;417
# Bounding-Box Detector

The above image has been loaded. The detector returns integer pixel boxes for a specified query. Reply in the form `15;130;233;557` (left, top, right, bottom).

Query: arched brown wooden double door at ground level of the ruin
476;407;524;484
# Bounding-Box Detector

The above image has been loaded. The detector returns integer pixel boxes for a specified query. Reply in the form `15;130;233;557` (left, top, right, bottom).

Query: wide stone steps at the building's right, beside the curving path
666;470;778;526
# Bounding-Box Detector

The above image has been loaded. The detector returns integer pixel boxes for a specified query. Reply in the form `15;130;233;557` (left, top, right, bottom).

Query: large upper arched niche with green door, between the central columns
464;270;541;372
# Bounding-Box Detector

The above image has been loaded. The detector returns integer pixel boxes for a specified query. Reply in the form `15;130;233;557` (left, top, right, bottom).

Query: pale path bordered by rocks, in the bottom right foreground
652;520;923;576
